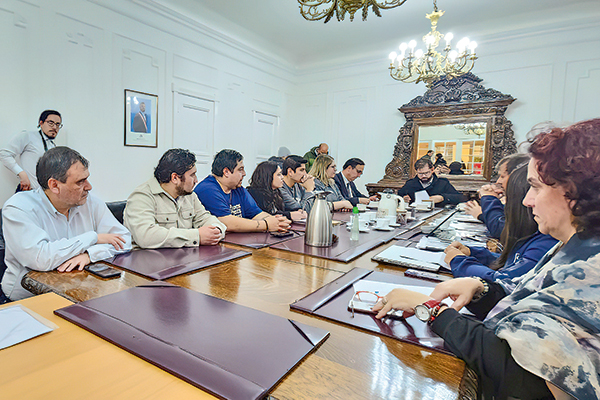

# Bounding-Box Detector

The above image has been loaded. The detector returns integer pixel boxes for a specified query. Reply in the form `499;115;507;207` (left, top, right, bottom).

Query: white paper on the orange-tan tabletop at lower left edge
0;304;58;349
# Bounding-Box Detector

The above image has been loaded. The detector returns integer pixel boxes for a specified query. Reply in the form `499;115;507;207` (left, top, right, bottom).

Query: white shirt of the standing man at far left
0;130;56;189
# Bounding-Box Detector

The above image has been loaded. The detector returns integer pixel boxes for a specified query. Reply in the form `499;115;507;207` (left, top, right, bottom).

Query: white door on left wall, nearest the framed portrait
173;92;215;181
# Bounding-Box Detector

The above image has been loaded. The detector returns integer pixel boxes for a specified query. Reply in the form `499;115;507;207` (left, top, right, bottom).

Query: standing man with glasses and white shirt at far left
0;110;63;192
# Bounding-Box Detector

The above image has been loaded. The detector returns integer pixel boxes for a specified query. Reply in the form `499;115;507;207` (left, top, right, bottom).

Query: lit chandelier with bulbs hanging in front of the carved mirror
389;0;477;88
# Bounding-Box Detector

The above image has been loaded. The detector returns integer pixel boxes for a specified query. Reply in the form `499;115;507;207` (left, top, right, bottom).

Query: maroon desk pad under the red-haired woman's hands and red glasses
290;268;452;354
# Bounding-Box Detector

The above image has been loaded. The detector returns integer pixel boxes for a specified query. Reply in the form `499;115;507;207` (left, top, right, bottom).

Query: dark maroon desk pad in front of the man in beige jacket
103;245;252;280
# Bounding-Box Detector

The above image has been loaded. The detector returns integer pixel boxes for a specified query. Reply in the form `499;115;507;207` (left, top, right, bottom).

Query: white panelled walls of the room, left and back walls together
0;0;600;203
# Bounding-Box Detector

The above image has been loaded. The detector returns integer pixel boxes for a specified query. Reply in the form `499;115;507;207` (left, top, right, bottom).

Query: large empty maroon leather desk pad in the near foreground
55;282;329;400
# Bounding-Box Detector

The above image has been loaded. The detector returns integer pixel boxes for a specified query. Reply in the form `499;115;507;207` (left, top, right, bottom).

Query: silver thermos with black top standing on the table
304;192;333;247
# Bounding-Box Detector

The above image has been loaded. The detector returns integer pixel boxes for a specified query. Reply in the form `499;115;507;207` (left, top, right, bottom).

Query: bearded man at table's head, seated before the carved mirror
398;158;465;206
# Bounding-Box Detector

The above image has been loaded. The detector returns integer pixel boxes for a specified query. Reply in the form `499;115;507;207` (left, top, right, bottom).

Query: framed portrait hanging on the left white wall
125;89;158;147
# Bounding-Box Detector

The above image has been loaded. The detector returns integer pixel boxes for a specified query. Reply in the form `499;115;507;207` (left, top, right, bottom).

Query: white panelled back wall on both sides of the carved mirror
288;21;600;194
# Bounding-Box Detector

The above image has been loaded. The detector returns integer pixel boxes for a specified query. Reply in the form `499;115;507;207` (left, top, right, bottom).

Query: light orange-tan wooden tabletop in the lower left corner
0;293;215;399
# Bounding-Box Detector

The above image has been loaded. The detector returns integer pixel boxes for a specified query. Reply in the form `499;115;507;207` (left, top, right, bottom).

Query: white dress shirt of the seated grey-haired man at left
2;188;131;300
